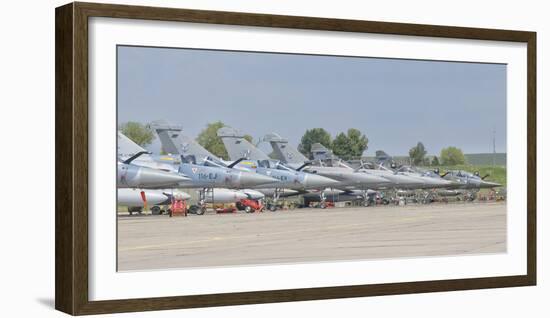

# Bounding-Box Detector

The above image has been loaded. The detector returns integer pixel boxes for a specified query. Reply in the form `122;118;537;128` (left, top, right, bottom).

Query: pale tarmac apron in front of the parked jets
118;202;506;271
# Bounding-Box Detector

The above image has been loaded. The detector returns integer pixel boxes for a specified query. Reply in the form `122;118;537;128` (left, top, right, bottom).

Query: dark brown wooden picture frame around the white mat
55;2;536;315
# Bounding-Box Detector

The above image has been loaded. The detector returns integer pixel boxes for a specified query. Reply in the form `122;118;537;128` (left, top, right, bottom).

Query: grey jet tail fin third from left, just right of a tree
218;127;270;160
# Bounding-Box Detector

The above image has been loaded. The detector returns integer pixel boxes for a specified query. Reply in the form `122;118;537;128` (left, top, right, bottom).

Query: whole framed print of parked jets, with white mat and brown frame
55;2;536;315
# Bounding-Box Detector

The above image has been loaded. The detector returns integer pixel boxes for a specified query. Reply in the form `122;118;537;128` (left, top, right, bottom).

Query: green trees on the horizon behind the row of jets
119;121;465;166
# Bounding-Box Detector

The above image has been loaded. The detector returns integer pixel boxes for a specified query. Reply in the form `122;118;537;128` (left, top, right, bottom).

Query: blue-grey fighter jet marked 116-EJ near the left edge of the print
118;132;277;214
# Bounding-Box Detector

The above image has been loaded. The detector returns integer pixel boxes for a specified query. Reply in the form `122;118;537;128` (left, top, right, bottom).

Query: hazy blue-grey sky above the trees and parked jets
117;46;506;156
